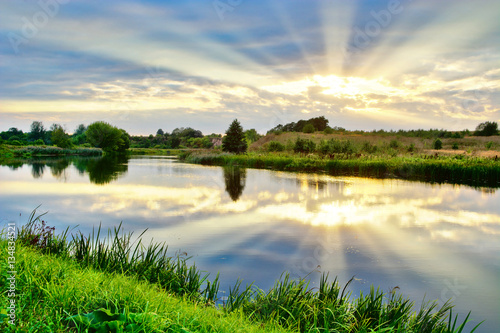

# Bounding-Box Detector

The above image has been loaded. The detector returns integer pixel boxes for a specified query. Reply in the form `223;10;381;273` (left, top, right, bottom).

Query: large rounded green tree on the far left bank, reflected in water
86;121;130;152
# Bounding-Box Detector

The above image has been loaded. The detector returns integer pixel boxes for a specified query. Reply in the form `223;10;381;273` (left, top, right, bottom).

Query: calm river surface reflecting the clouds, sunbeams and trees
0;157;500;332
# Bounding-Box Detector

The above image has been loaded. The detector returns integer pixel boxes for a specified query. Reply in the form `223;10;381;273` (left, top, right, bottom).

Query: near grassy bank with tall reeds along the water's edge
0;210;484;333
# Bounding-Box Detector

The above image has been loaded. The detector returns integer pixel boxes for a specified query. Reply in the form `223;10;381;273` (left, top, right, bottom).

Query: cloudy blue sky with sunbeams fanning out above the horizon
0;0;500;135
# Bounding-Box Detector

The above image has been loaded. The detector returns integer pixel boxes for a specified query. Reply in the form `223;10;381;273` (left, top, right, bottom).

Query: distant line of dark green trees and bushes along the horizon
0;116;499;153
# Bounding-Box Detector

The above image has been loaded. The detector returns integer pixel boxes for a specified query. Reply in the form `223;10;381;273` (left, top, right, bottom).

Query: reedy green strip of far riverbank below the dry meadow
180;151;500;187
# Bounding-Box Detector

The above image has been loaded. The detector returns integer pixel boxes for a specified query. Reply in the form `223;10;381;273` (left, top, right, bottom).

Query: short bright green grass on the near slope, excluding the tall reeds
0;240;292;333
